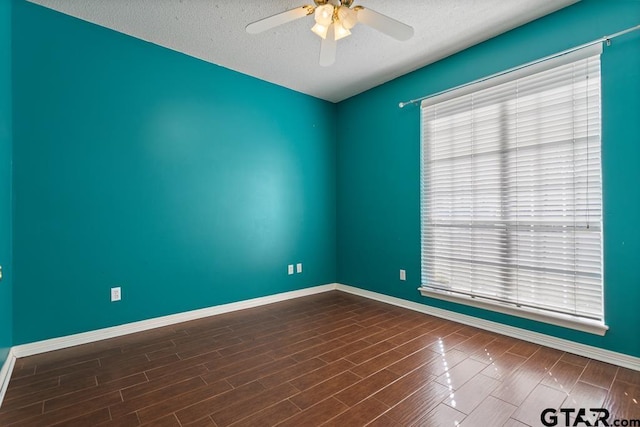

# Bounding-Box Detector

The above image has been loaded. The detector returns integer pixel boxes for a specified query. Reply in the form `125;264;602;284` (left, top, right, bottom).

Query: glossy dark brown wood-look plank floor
0;291;640;427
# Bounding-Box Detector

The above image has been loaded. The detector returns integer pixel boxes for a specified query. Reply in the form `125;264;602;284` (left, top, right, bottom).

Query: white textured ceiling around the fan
30;0;577;102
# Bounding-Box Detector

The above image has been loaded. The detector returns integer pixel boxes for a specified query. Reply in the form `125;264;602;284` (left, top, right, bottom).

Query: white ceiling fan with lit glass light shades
246;0;413;67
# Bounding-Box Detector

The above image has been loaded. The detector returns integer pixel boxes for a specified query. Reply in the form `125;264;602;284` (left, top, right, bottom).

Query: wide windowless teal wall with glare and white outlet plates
13;1;336;344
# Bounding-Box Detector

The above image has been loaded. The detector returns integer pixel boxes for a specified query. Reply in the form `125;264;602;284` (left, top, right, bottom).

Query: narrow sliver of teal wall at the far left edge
0;0;13;368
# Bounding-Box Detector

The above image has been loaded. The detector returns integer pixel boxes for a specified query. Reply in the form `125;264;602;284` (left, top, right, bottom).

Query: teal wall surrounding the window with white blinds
337;0;640;356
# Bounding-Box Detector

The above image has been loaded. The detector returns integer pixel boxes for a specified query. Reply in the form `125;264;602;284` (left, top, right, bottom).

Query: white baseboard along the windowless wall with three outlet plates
12;283;337;357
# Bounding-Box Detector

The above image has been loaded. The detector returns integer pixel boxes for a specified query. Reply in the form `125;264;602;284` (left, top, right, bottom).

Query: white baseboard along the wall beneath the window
336;284;640;371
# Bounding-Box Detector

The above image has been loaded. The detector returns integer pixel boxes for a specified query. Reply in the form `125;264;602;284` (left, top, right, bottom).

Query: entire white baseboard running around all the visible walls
6;283;640;378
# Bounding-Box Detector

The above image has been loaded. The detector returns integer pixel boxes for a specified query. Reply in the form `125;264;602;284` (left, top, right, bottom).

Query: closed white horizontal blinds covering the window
421;45;603;320
